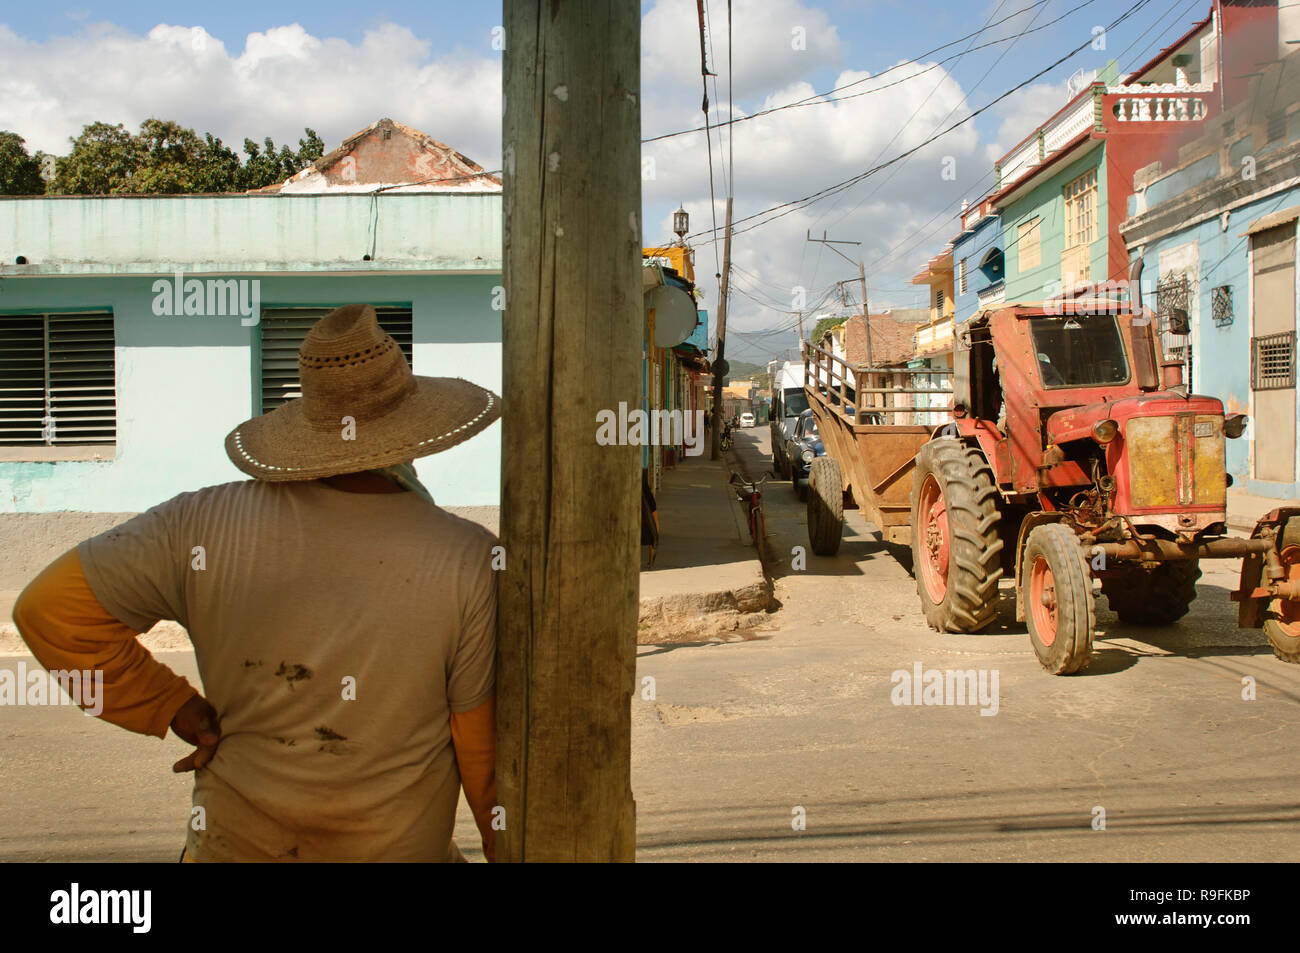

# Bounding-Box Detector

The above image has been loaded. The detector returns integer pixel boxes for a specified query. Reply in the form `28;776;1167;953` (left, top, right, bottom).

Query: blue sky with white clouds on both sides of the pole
0;0;1210;361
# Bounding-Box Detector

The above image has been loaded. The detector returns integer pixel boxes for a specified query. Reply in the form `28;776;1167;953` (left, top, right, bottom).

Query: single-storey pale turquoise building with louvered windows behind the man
0;191;504;517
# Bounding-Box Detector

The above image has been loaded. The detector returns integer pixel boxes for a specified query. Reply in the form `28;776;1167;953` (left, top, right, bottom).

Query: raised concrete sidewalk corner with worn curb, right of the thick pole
637;444;772;645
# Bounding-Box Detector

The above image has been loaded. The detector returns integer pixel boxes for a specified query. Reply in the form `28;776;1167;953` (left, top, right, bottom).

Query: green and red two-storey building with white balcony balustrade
989;0;1278;300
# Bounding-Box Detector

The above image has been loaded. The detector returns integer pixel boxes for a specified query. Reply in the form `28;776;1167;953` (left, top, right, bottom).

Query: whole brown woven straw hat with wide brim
226;304;501;482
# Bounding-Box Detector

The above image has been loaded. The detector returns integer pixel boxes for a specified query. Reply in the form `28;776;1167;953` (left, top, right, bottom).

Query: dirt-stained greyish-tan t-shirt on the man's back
78;481;497;862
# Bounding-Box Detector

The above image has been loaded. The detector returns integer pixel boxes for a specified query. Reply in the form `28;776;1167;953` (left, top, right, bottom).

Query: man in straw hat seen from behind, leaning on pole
13;304;501;862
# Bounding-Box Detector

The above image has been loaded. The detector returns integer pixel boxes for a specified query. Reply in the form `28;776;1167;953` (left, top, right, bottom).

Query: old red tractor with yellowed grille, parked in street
910;293;1300;675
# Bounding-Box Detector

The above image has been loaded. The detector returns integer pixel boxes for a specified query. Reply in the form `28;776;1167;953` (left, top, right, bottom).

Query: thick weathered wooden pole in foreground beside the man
497;0;645;861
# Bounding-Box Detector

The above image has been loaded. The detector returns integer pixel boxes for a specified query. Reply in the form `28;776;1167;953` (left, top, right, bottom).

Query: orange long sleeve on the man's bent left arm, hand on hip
13;550;196;738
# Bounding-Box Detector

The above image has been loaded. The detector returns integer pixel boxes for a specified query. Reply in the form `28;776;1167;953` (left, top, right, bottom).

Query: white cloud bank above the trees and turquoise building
0;23;501;168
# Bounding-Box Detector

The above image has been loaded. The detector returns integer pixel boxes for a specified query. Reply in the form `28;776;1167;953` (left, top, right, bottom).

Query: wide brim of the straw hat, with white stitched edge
226;377;501;482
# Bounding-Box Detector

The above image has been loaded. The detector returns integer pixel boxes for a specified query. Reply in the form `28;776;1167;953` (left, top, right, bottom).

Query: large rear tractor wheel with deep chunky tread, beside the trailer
911;438;1002;632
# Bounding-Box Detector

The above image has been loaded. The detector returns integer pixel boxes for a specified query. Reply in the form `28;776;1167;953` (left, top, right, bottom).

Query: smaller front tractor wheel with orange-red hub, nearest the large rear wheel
1021;523;1097;675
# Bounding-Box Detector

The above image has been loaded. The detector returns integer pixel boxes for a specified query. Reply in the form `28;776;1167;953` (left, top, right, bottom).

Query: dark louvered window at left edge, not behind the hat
0;312;117;446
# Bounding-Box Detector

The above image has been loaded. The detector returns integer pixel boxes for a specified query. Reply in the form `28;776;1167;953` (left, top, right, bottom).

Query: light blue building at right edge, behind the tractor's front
1121;44;1300;498
